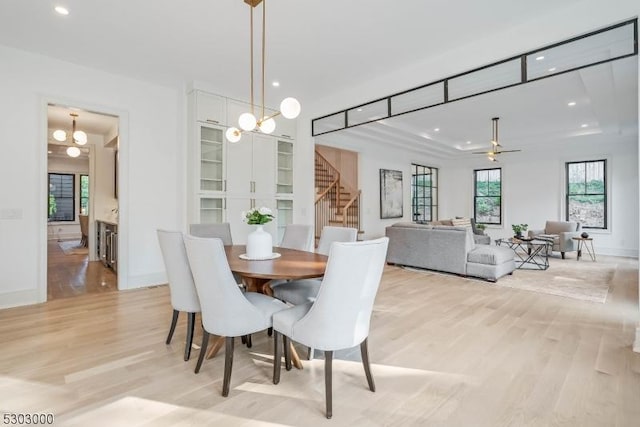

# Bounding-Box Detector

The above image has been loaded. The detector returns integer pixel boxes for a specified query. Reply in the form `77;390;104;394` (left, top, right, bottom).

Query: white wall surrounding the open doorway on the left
0;47;185;307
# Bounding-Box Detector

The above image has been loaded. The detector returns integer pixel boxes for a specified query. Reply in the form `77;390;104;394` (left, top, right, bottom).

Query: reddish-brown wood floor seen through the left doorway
47;240;118;301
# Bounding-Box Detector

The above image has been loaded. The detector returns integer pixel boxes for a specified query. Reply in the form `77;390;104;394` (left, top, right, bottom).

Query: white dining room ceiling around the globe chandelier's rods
0;0;592;105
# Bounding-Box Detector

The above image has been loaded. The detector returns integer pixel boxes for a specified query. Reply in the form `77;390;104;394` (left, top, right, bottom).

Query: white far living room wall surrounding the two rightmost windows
440;134;640;257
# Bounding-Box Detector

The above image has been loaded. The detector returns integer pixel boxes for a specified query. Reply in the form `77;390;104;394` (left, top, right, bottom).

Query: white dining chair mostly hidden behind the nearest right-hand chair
270;226;358;305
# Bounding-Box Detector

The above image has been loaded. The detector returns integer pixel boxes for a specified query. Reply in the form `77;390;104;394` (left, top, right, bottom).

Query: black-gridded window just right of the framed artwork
411;164;438;222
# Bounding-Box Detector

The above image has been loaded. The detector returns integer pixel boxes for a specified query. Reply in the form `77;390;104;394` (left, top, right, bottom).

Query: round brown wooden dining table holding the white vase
207;245;328;369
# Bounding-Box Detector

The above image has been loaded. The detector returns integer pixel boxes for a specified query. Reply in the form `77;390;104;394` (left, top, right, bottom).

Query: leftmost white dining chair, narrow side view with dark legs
158;230;200;361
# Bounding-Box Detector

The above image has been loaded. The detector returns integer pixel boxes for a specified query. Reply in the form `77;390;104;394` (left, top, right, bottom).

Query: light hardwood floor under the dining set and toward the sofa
0;257;640;427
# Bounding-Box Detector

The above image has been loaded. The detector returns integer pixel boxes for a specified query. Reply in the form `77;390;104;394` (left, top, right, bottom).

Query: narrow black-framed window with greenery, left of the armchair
473;168;502;224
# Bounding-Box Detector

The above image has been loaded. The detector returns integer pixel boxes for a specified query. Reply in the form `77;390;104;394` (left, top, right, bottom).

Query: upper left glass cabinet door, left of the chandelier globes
200;126;224;191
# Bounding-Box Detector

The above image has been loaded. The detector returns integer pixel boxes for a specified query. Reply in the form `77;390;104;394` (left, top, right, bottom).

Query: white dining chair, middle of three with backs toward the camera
184;236;286;396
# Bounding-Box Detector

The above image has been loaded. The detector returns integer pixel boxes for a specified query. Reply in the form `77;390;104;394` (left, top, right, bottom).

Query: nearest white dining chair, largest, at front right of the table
273;237;389;418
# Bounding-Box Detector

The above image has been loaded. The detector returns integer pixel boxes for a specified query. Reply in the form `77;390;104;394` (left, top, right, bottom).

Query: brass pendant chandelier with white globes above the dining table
225;0;300;142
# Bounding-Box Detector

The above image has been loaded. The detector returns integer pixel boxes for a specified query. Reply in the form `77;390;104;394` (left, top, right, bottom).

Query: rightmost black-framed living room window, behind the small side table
565;160;607;229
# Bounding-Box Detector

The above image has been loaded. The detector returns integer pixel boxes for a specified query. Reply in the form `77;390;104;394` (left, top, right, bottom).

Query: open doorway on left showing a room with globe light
46;104;119;300
